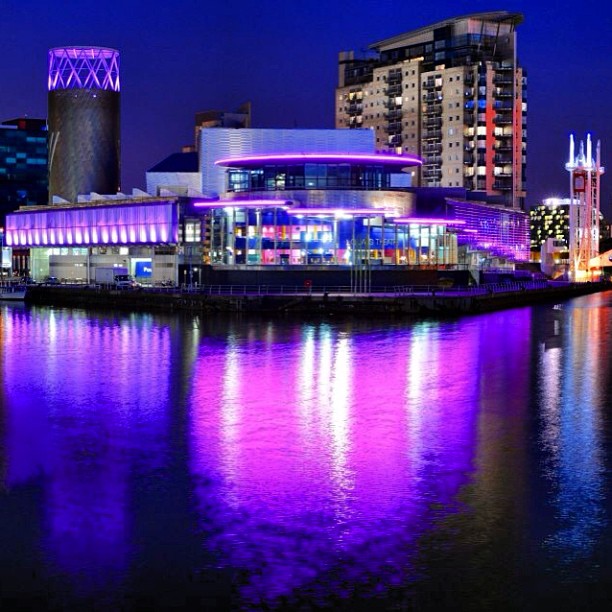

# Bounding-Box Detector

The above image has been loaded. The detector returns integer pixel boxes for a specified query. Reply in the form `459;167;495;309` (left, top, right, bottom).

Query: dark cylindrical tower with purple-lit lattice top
48;47;121;201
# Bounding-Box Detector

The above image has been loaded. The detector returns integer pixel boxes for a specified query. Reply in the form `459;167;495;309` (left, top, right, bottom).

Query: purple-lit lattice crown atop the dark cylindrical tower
48;47;119;91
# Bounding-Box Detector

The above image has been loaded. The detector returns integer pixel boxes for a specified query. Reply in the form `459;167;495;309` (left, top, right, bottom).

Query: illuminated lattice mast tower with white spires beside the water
565;134;604;281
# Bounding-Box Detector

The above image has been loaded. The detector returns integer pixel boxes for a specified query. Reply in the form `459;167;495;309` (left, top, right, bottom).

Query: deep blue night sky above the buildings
0;0;612;212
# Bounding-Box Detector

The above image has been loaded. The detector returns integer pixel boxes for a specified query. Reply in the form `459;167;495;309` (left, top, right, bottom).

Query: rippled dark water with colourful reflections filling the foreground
0;292;612;610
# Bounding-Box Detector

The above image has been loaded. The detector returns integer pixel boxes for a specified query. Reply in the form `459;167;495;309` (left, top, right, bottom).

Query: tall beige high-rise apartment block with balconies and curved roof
336;11;527;209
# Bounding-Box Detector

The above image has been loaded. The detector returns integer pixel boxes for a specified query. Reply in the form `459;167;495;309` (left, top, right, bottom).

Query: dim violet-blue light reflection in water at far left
1;310;169;593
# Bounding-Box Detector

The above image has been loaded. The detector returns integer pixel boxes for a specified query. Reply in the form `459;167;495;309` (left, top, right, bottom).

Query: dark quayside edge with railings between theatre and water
22;281;612;316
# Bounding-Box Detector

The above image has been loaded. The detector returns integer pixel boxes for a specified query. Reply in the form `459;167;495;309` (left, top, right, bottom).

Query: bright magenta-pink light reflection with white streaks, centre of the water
191;325;479;605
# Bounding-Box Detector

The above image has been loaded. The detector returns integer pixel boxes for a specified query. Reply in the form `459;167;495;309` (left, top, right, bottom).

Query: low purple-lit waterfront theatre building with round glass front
6;128;529;284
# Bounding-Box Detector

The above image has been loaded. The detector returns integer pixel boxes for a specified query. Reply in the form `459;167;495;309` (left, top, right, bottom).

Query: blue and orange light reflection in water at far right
538;296;610;576
